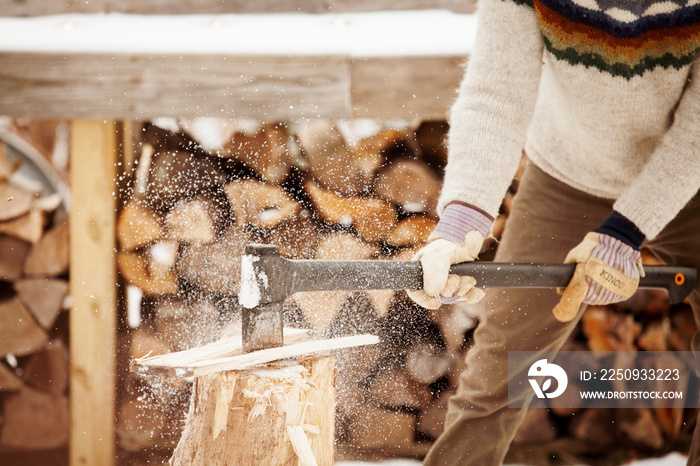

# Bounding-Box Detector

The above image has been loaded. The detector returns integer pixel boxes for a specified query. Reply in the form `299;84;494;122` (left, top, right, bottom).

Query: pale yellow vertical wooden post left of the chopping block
70;120;117;466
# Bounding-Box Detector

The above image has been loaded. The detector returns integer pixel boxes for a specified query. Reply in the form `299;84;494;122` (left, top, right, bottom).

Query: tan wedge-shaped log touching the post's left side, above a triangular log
24;222;69;277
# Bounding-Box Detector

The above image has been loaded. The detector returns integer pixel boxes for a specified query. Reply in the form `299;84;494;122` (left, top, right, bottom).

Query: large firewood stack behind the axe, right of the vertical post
117;120;692;464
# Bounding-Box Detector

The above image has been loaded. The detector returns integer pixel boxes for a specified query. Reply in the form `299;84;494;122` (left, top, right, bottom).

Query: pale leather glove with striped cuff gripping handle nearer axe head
406;203;493;309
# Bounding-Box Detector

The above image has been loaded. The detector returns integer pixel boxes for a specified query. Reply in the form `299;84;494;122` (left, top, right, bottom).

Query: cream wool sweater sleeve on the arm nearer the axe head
438;0;544;217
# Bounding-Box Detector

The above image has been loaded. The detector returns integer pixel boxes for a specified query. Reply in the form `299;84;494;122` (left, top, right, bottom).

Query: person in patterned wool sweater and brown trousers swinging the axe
409;0;700;466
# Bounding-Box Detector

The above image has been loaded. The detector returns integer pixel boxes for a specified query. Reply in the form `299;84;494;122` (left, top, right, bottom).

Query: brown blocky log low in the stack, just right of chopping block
350;406;416;450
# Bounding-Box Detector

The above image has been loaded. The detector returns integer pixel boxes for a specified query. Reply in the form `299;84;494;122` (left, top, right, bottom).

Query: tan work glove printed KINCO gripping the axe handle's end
552;212;644;322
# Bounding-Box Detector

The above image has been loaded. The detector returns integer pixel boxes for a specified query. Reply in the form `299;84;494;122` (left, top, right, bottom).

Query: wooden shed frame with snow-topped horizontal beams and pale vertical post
0;0;473;466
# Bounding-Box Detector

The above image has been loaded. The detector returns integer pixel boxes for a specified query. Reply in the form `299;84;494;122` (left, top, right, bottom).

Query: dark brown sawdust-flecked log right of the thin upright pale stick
147;151;226;209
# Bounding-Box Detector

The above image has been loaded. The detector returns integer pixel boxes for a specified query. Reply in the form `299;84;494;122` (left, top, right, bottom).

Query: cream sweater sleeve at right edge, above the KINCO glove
614;54;700;239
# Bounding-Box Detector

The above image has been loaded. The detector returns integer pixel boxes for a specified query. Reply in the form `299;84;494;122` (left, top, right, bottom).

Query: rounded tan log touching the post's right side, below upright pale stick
117;199;163;251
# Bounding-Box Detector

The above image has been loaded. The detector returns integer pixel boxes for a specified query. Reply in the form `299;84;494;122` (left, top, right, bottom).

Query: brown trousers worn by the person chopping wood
424;163;700;466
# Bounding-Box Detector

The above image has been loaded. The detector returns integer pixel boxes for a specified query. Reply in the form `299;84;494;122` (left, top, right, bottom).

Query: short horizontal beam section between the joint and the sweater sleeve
351;56;465;120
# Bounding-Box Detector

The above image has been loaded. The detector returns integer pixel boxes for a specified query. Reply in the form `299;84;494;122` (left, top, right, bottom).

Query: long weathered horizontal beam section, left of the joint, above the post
0;53;350;121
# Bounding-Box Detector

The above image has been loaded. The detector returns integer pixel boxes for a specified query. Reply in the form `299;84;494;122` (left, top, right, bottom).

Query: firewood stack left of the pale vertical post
0;137;69;464
